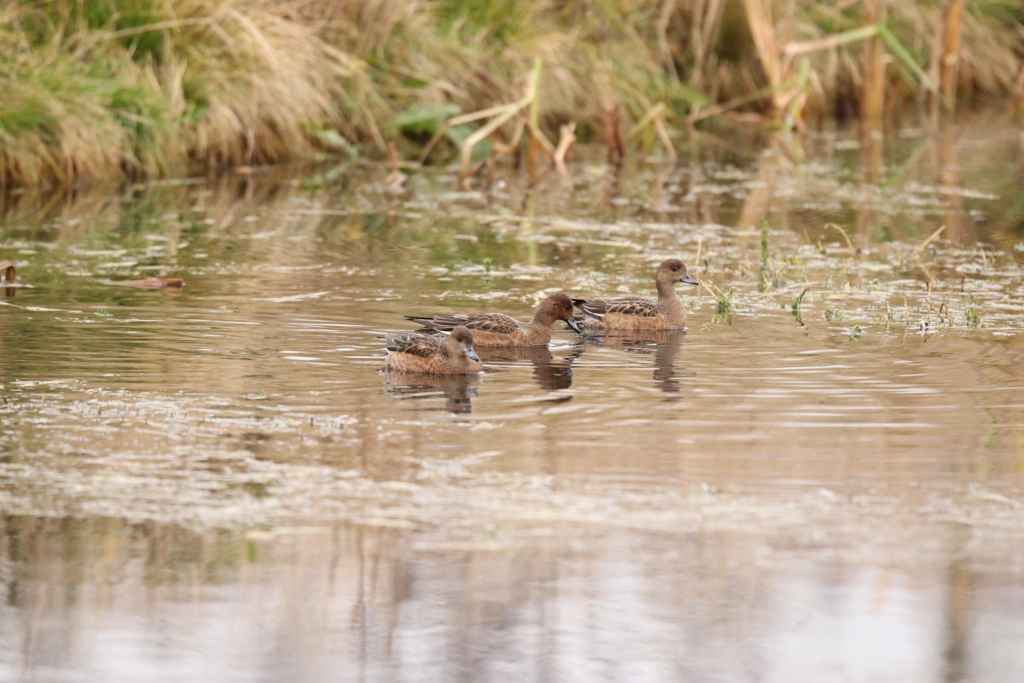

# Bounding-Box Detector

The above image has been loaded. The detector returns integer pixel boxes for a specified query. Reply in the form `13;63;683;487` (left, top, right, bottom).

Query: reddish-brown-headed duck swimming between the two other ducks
404;292;583;348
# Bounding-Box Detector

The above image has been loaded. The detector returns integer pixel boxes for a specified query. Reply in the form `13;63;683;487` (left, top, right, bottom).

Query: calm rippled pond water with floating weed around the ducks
0;121;1024;682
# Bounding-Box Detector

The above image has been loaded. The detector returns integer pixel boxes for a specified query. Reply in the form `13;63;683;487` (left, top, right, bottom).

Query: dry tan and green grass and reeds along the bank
0;0;1024;188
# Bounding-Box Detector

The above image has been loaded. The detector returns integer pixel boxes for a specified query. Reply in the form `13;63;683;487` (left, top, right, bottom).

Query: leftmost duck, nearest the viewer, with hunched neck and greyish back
384;326;483;375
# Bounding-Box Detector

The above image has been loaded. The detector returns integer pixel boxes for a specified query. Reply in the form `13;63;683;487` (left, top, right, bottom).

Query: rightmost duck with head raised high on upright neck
572;258;699;331
